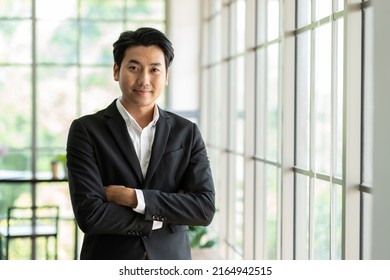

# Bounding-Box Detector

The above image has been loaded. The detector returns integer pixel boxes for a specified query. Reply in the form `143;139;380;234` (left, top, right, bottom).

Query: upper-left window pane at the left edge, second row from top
0;20;32;64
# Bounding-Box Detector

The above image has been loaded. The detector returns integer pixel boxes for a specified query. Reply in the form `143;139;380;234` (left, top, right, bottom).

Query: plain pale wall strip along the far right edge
372;0;390;259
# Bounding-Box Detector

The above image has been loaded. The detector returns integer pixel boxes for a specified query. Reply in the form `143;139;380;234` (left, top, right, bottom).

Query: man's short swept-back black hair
113;27;174;68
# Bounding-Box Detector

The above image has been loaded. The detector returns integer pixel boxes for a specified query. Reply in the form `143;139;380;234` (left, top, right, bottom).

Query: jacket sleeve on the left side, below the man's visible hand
67;119;152;236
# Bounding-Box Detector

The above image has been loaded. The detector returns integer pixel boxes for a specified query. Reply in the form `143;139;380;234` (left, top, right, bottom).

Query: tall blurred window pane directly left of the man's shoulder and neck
37;67;77;147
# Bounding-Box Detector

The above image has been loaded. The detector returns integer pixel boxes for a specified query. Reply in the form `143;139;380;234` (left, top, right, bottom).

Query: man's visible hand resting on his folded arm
104;185;138;208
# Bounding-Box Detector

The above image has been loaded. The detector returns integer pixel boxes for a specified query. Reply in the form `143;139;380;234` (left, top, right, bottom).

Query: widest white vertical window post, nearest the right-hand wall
342;0;362;260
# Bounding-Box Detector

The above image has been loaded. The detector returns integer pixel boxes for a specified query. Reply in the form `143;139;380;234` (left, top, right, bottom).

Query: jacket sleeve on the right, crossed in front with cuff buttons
143;124;215;226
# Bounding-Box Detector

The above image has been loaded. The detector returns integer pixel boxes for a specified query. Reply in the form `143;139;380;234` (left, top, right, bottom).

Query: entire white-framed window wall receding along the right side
202;0;372;259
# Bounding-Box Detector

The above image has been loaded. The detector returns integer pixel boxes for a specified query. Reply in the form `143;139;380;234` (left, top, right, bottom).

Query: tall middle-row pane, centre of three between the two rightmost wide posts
314;24;332;174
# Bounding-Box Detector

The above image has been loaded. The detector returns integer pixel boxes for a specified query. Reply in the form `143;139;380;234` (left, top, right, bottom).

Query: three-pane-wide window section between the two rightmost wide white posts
295;1;344;259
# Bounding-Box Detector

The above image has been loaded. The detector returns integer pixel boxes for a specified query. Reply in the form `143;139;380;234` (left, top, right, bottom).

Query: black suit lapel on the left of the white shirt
105;101;143;183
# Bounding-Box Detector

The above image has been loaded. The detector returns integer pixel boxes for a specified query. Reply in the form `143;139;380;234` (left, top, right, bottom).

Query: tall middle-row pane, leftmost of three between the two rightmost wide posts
295;32;311;170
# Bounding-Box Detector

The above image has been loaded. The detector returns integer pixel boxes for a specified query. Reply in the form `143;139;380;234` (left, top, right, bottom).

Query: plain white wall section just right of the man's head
167;0;201;116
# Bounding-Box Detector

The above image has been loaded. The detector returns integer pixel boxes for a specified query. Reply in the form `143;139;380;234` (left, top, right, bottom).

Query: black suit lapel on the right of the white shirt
142;108;171;187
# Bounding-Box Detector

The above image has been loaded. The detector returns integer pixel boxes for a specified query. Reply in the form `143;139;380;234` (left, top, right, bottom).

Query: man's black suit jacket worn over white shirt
67;101;215;259
